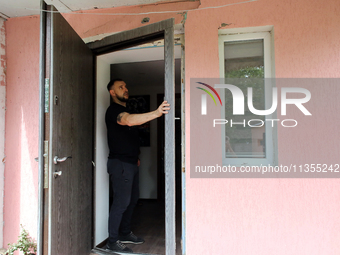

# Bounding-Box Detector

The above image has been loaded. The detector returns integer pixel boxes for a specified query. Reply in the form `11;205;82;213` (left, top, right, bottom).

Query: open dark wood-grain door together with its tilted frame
38;3;176;255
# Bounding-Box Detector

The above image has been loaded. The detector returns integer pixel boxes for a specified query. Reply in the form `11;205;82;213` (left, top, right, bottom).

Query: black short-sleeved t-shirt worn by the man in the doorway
105;102;139;164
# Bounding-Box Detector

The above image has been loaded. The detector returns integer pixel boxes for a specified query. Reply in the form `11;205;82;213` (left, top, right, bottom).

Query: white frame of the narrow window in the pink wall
218;26;277;166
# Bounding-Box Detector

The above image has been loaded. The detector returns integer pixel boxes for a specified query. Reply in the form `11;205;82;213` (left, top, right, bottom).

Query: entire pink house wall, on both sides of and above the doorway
4;0;340;254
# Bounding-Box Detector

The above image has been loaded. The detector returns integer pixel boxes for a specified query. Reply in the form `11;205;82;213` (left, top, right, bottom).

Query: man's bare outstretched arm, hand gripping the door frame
117;101;170;126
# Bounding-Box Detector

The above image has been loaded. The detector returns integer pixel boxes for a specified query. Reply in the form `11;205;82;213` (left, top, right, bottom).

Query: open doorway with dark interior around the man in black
94;42;182;254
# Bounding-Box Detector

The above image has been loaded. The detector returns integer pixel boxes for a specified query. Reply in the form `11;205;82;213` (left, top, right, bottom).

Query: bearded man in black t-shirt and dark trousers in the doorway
105;79;170;252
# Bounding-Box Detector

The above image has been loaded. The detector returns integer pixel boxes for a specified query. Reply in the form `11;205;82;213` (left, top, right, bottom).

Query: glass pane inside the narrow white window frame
224;39;266;158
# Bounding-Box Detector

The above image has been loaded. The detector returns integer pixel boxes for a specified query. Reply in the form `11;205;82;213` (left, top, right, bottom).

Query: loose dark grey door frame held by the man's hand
87;18;176;255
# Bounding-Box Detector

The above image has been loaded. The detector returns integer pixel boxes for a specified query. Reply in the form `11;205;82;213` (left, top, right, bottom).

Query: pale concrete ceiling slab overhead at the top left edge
0;0;192;18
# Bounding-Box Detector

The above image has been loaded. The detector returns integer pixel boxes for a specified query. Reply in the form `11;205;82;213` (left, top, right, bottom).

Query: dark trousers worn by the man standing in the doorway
107;159;139;243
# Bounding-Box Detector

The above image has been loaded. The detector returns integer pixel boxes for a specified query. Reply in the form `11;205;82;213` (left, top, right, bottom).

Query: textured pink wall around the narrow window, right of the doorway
185;0;340;255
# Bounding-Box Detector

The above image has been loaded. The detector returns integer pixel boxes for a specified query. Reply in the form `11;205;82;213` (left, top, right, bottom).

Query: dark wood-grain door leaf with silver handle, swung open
46;7;94;255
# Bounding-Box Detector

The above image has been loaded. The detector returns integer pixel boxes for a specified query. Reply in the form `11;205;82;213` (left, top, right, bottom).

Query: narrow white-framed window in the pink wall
219;30;277;166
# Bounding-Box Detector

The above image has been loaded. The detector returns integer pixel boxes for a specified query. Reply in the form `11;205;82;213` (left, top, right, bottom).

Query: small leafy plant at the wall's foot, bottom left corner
6;225;37;255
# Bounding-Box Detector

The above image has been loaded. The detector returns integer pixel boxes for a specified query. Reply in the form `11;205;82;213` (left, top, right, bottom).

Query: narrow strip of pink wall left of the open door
4;17;39;246
